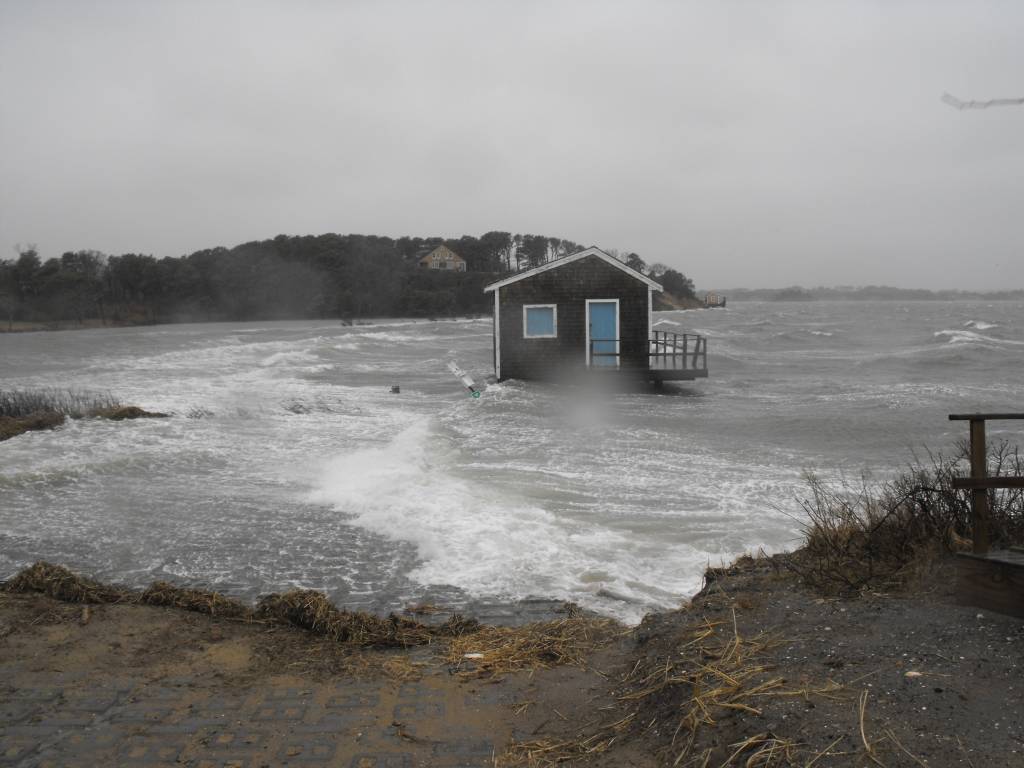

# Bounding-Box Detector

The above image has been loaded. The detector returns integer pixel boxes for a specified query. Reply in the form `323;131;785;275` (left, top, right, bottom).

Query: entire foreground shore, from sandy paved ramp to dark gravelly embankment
0;558;1024;768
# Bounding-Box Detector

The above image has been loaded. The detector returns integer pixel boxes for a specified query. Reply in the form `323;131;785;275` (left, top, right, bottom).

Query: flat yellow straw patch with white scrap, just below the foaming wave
447;615;623;677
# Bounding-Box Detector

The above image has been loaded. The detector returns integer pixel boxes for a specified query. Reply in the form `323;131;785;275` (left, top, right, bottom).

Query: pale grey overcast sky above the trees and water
0;0;1024;289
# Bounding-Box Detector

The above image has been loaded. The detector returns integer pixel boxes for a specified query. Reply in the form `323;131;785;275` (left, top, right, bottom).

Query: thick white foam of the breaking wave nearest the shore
311;418;706;621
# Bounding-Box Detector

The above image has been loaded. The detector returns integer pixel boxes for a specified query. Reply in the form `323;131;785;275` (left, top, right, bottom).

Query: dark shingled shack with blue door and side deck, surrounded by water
483;248;708;384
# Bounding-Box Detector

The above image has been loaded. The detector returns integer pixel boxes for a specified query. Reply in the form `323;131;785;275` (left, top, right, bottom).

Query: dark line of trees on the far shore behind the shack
0;231;693;328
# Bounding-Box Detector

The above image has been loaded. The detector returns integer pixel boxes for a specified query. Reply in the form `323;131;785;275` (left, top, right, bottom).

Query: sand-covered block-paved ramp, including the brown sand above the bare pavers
0;595;593;768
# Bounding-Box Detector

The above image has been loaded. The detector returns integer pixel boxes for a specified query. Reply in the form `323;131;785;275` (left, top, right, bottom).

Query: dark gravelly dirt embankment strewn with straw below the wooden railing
569;555;1024;768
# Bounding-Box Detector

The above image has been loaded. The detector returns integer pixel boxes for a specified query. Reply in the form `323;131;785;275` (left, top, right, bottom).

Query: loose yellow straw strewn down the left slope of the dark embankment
498;620;840;768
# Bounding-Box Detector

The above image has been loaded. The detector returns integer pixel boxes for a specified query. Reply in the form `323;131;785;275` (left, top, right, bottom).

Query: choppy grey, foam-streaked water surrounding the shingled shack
0;302;1024;621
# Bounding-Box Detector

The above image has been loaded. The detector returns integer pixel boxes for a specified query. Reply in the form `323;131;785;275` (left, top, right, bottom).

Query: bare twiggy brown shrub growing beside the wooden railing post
787;442;1024;595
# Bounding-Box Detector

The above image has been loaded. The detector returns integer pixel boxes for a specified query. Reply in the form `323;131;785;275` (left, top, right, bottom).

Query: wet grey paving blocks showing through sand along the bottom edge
0;676;508;768
